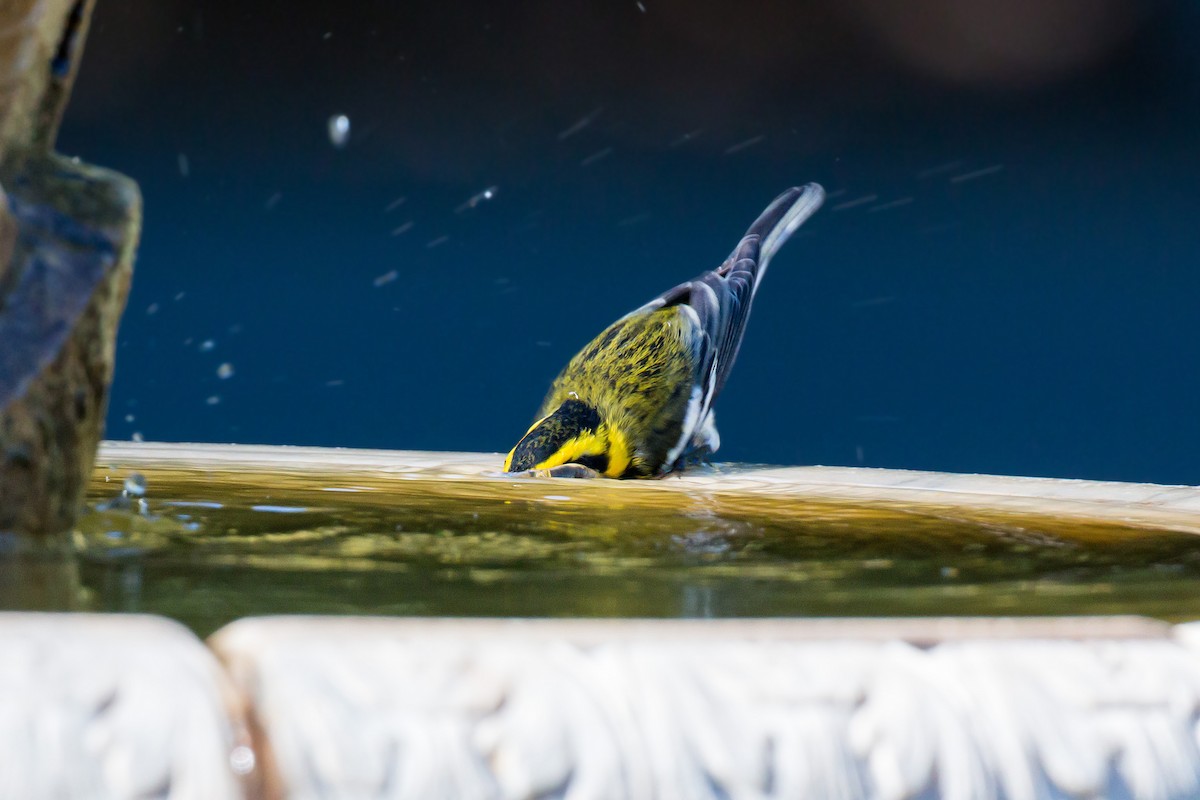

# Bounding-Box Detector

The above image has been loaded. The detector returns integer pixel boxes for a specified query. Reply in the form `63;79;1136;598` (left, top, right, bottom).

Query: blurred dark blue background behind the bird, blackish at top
60;0;1200;483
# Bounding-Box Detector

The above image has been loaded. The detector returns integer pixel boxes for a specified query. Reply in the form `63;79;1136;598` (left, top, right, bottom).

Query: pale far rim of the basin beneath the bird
96;441;1200;534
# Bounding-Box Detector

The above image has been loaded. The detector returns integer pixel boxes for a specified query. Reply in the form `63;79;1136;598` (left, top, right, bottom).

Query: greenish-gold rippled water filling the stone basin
60;462;1200;634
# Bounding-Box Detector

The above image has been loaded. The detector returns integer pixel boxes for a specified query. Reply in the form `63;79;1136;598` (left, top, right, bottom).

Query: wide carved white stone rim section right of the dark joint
211;618;1200;800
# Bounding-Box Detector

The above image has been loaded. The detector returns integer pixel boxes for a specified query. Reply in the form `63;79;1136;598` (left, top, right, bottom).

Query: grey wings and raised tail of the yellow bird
631;184;824;402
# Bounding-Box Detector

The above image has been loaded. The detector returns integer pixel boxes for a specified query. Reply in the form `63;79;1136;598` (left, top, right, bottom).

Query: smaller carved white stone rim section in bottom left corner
0;613;248;800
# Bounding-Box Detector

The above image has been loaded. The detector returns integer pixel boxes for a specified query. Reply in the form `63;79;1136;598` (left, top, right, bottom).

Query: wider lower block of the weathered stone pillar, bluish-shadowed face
0;156;140;534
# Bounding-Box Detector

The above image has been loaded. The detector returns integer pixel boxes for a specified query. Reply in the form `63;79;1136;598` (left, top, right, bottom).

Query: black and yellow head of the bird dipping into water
504;398;630;477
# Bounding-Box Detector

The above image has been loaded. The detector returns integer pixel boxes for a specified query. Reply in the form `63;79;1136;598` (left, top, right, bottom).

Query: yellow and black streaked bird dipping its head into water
504;184;824;479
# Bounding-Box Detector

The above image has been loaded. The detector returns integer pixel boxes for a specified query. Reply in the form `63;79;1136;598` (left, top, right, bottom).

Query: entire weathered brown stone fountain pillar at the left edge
0;0;142;535
